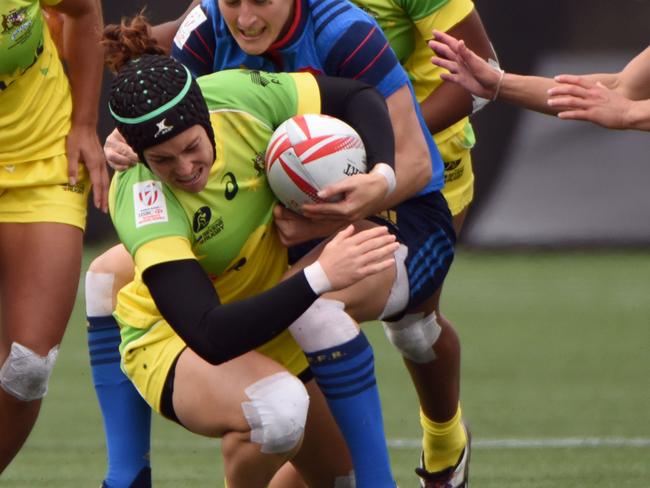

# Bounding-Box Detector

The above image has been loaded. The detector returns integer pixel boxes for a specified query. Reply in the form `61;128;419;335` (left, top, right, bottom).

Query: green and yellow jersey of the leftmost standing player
0;0;72;165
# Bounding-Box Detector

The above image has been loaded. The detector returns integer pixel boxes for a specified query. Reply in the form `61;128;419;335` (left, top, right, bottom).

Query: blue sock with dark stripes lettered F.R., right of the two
307;332;395;488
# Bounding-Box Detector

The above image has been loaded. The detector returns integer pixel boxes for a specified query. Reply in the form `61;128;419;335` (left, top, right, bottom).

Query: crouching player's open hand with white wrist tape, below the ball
318;225;399;290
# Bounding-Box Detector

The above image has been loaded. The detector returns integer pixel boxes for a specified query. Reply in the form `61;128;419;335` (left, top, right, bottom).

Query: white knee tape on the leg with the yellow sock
382;312;441;364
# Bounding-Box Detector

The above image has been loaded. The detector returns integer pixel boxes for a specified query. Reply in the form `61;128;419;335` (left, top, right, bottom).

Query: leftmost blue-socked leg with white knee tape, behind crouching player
85;244;151;488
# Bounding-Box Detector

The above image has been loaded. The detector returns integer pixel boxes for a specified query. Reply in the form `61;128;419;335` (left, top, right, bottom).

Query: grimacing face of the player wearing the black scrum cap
144;125;214;193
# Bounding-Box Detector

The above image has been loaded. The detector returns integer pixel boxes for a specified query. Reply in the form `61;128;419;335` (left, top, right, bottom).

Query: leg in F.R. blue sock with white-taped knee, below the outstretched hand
289;223;396;488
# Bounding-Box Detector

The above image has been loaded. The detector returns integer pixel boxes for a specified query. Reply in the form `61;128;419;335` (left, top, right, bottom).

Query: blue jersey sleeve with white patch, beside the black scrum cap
172;0;217;78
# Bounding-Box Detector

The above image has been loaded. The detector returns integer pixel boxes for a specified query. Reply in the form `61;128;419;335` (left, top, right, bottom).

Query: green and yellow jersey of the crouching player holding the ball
109;70;320;408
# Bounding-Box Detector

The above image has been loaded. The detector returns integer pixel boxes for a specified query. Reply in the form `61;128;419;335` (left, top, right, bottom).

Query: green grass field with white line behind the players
0;249;650;488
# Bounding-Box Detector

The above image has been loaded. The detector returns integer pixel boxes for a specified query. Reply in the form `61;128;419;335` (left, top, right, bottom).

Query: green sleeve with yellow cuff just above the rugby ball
197;70;321;129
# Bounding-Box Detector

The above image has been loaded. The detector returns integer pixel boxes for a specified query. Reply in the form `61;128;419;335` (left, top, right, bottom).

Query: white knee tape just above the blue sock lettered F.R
289;298;359;353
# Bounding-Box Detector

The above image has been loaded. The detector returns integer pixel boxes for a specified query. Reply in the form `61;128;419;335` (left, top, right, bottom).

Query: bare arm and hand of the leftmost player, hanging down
53;0;108;211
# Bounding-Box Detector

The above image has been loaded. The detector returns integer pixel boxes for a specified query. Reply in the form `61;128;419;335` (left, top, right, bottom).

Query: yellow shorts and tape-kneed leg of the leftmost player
0;160;90;472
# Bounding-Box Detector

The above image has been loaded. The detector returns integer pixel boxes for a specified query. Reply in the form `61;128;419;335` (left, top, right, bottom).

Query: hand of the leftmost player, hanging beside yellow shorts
66;125;109;212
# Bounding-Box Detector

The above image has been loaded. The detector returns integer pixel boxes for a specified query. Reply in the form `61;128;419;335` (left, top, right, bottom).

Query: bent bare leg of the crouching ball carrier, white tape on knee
170;348;309;488
